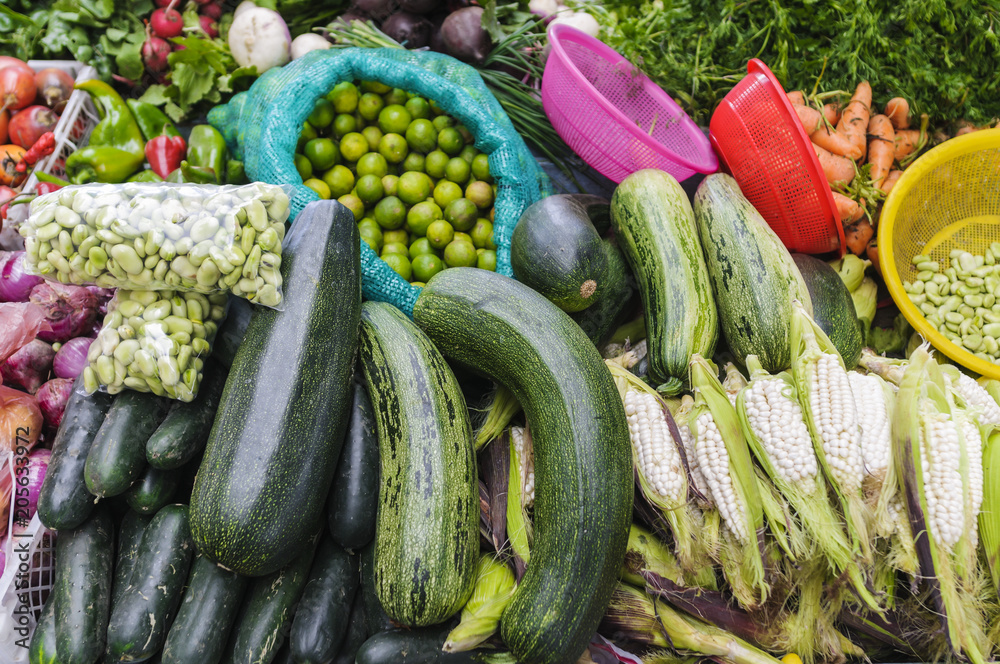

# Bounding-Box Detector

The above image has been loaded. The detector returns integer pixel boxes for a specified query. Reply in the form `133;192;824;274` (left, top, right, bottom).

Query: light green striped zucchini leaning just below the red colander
694;173;812;373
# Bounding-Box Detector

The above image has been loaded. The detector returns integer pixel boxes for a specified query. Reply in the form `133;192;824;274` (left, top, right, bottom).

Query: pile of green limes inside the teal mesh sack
295;81;496;285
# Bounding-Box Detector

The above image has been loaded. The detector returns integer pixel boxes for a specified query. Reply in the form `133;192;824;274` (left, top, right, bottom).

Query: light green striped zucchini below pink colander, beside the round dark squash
611;169;719;396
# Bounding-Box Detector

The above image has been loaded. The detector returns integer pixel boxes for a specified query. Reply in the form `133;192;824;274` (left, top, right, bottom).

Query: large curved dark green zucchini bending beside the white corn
414;268;633;664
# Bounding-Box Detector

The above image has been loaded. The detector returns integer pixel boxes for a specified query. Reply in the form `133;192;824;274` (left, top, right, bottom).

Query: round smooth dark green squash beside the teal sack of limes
510;194;611;312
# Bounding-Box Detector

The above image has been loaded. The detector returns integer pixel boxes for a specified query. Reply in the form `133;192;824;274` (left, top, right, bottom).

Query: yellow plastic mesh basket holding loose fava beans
878;129;1000;379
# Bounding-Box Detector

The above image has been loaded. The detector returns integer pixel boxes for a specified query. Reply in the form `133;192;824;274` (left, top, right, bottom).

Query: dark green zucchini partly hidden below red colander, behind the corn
792;254;865;369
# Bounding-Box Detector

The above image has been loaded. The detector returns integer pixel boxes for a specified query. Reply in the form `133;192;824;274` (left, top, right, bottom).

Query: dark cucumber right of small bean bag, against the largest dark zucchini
146;360;227;470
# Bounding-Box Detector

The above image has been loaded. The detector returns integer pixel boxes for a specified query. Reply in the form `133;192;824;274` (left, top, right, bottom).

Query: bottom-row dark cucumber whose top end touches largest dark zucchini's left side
108;505;194;662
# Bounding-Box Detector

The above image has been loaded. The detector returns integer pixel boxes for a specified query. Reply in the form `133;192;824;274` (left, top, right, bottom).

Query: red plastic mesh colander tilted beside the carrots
709;58;845;255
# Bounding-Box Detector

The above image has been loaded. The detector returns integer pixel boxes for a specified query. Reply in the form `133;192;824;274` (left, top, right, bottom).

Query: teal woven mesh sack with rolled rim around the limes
208;48;551;316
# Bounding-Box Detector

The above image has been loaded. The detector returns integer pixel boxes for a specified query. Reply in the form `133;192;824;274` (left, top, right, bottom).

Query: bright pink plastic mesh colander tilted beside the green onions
542;23;719;182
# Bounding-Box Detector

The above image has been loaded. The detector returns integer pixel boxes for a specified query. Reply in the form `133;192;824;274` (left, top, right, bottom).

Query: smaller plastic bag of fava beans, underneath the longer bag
83;289;228;401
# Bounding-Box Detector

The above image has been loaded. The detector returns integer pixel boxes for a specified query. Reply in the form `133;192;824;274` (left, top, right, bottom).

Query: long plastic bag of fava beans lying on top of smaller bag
20;182;289;307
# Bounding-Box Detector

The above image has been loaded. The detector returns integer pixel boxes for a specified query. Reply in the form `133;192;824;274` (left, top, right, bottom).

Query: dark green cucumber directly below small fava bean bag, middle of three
83;390;170;498
